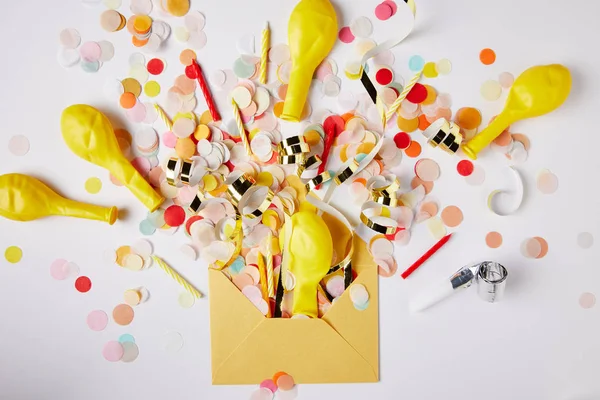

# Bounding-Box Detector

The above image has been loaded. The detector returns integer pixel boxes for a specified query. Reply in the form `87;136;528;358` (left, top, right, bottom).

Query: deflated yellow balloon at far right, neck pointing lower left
462;64;571;160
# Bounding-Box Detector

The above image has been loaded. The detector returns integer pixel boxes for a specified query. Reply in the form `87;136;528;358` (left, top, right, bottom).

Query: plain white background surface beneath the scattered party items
0;0;600;400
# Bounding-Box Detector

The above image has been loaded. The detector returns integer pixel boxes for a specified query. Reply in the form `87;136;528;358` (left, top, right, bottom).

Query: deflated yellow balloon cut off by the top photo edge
281;0;338;122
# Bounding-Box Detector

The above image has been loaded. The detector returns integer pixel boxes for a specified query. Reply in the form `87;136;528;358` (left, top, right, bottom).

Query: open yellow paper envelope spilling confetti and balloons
209;237;379;385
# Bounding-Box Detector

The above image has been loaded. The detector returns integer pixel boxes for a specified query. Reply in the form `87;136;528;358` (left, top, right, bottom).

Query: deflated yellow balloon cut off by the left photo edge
0;174;118;225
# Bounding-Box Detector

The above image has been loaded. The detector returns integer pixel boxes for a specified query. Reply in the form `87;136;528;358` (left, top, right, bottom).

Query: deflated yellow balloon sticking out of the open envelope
281;211;333;318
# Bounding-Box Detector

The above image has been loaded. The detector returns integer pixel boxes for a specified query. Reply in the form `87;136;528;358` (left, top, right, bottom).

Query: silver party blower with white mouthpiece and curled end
410;261;508;313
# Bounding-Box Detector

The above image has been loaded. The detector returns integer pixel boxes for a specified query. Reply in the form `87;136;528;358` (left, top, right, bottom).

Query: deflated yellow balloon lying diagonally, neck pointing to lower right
60;104;165;212
